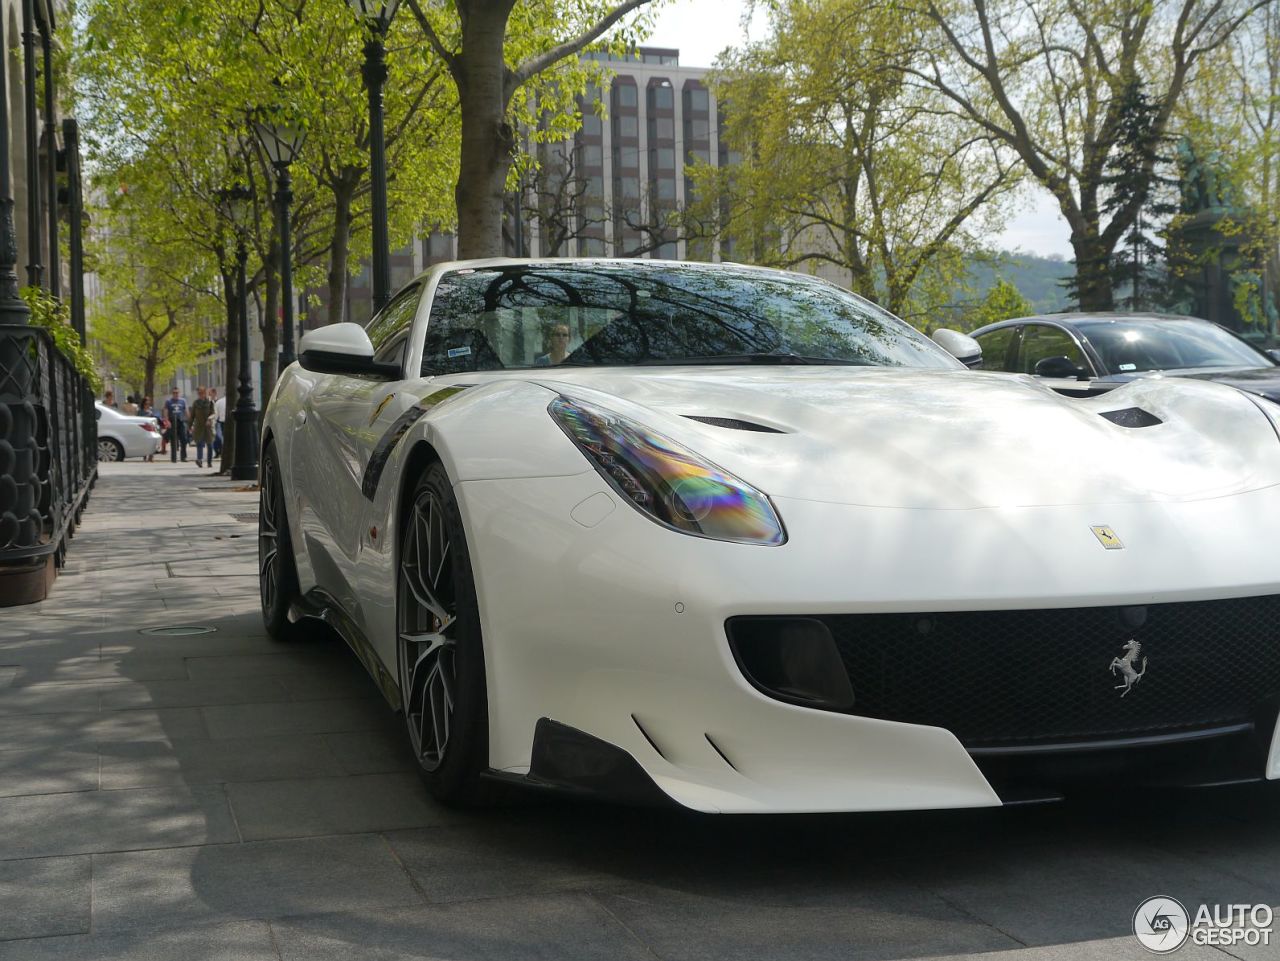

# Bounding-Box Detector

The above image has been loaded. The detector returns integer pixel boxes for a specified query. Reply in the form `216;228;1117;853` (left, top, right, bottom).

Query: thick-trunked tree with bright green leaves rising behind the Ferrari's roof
408;0;657;257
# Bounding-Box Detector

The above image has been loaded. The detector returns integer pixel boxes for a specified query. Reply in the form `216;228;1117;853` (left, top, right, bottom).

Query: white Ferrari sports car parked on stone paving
259;260;1280;813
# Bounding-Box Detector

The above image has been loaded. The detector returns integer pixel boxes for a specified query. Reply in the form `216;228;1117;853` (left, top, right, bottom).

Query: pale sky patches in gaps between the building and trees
645;0;1073;258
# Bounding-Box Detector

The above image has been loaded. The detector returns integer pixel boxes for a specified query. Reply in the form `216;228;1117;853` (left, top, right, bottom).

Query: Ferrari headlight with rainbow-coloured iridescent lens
547;397;787;544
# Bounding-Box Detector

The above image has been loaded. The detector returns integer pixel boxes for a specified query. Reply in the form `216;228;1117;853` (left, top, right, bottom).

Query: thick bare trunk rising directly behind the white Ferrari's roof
454;4;516;258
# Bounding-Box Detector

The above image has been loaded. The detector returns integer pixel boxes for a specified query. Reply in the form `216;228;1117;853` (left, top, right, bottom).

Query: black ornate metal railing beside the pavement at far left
0;325;97;607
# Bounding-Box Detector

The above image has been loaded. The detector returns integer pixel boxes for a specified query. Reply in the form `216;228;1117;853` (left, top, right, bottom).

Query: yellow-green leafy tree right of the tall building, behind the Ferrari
690;0;1016;314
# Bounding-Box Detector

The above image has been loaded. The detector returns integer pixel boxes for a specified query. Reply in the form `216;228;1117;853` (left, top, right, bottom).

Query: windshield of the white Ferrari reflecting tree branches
422;261;960;375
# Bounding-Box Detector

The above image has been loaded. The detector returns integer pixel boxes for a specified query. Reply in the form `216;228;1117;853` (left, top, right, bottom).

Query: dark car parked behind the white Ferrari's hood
972;314;1280;402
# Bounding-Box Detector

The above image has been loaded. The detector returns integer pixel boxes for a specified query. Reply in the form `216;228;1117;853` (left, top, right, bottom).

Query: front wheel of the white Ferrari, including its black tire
396;463;493;806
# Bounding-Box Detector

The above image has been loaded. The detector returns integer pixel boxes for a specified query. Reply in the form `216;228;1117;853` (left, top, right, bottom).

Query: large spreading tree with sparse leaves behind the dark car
913;0;1271;310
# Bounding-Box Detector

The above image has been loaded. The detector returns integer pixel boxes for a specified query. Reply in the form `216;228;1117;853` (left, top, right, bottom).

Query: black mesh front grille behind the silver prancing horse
818;595;1280;747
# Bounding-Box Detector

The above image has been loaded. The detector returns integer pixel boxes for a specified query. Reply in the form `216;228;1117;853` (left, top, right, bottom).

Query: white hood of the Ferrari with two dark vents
536;367;1280;509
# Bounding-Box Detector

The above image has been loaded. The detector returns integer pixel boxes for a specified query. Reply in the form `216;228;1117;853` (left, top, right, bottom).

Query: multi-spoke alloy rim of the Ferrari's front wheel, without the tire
399;489;458;772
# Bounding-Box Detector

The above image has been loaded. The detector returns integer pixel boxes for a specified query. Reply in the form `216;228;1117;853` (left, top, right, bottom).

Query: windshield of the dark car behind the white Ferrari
1076;320;1271;374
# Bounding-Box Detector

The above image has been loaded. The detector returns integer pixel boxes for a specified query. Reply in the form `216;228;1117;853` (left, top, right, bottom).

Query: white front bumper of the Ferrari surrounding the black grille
457;472;1280;811
